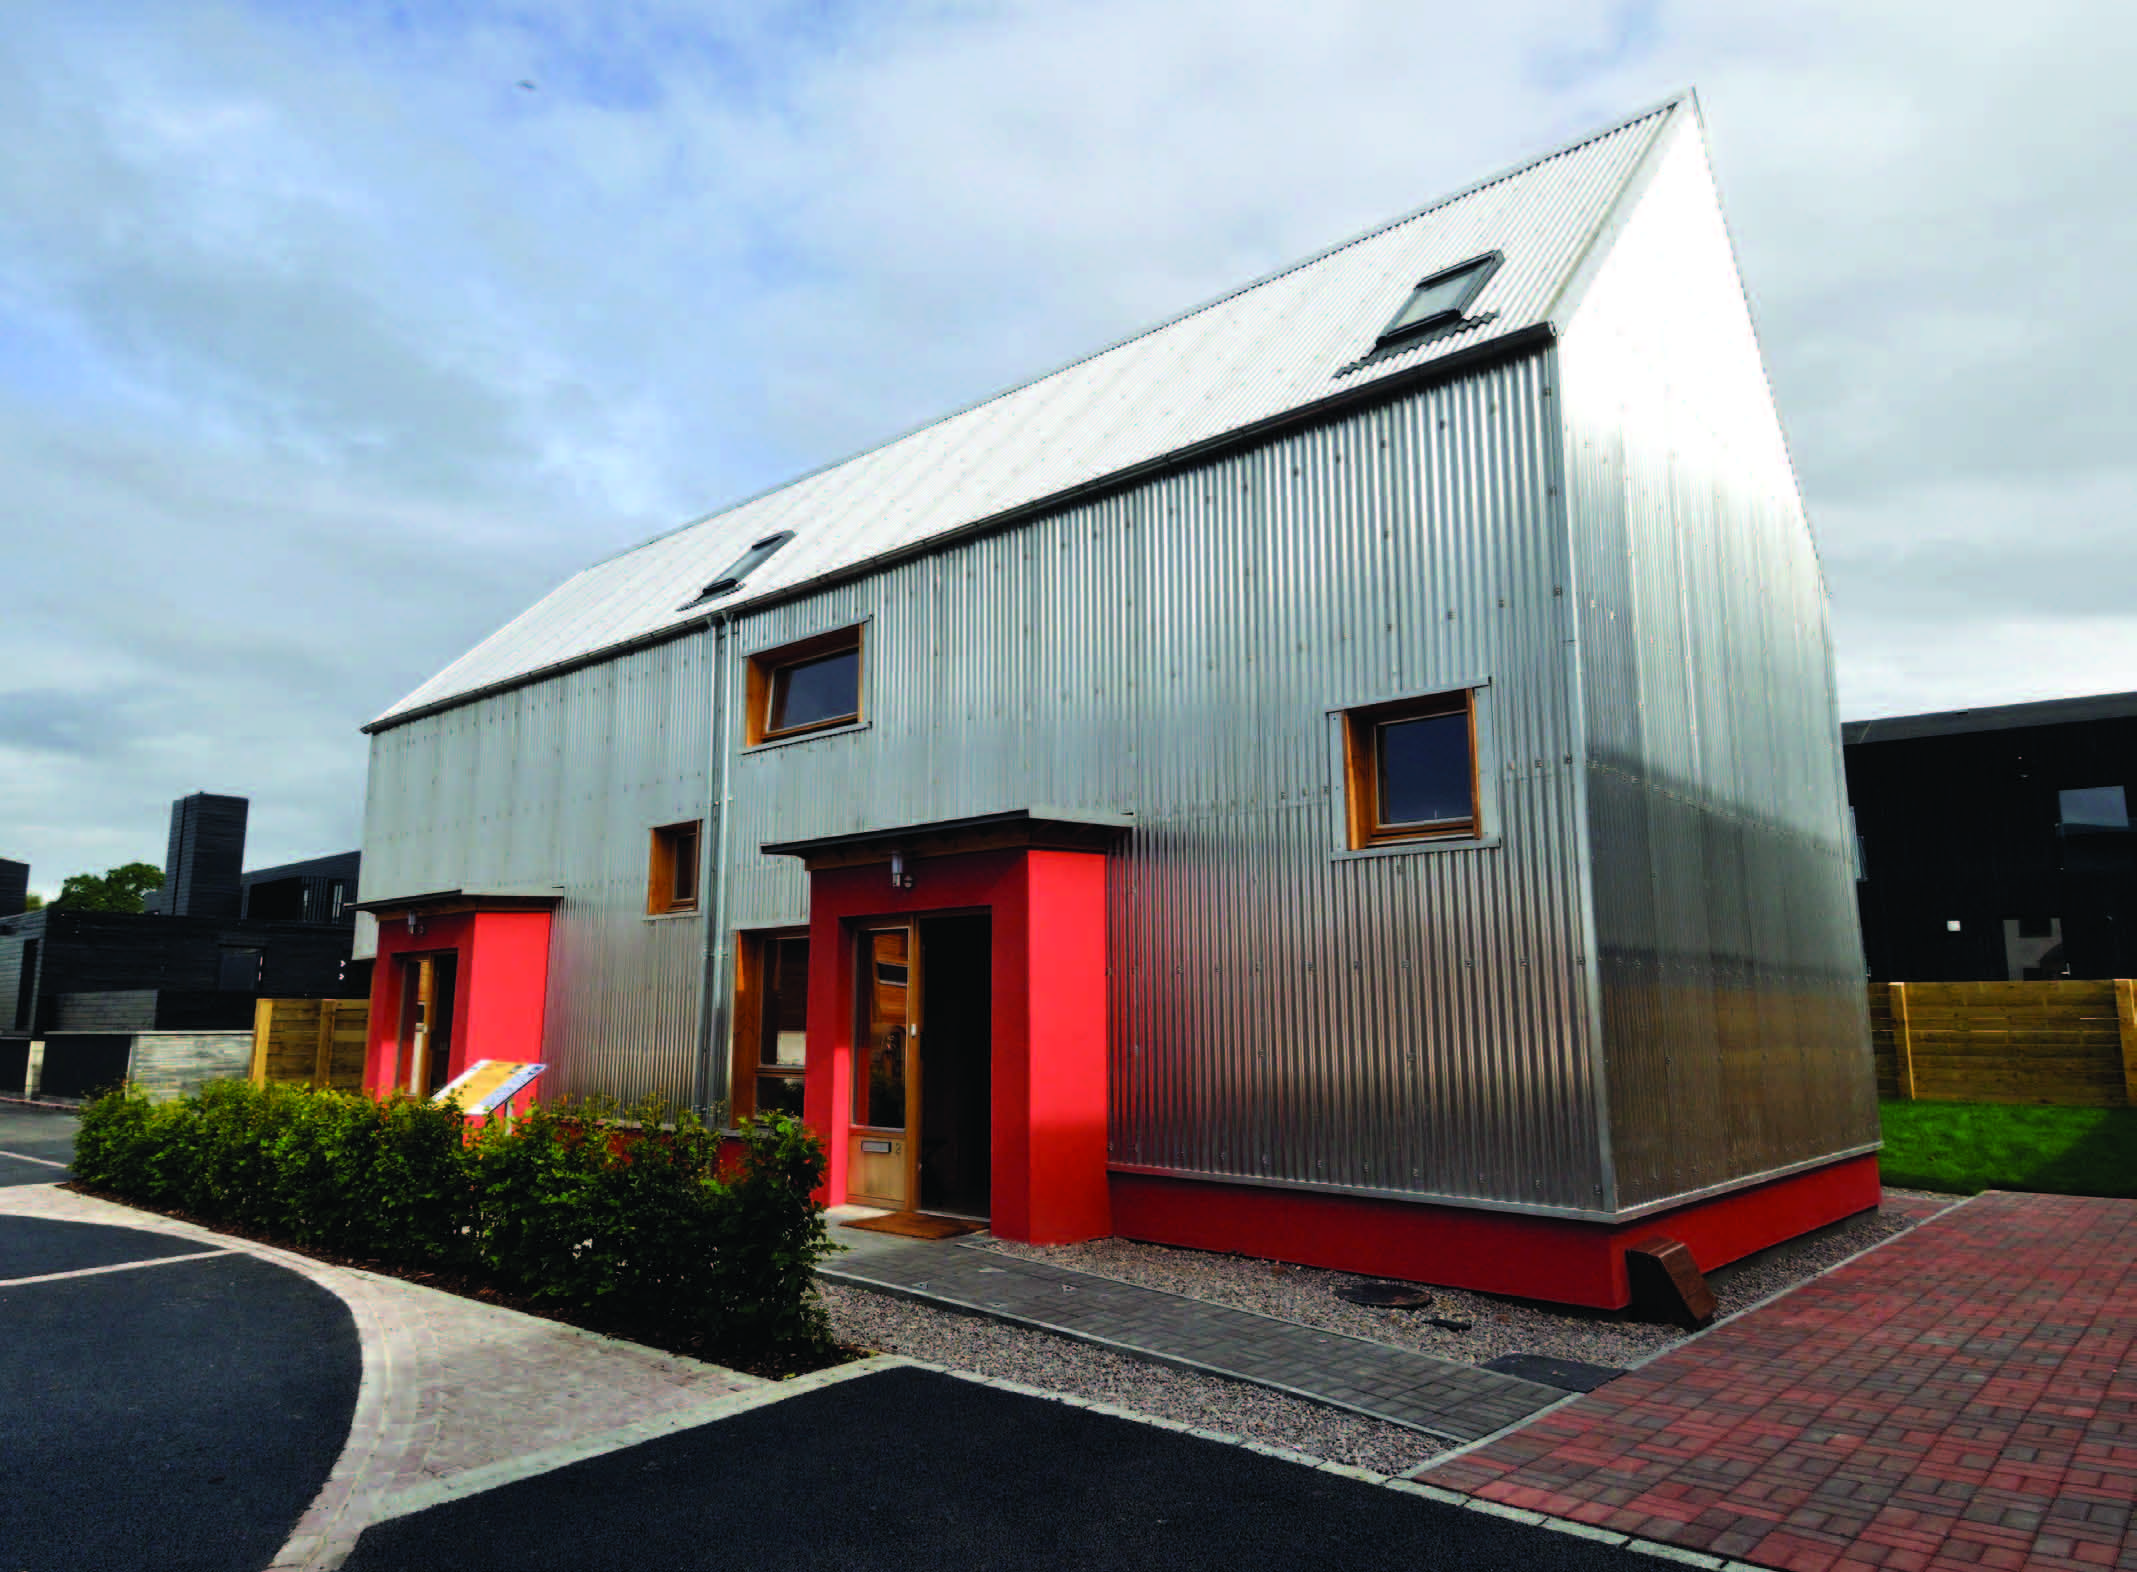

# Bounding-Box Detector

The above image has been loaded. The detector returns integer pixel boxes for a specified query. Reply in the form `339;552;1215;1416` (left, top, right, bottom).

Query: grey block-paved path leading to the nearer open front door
818;1228;1566;1442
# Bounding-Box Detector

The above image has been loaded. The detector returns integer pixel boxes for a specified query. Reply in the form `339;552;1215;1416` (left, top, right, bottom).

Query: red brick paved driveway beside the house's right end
1421;1194;2137;1572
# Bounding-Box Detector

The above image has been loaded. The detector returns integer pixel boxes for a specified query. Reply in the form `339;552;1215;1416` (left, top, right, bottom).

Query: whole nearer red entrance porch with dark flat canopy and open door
763;807;1133;1243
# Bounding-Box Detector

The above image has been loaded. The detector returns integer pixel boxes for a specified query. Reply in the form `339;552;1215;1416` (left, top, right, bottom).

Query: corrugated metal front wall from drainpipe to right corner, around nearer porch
726;357;1603;1209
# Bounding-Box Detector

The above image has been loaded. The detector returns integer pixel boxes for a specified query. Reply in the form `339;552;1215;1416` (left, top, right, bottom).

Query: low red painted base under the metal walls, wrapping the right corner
1111;1153;1883;1309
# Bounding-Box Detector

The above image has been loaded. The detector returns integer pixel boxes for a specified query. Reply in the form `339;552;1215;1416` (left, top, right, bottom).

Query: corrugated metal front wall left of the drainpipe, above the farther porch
363;632;712;1098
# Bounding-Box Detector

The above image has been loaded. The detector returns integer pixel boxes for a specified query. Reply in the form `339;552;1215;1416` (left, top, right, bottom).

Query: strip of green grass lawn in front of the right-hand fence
1878;1102;2137;1196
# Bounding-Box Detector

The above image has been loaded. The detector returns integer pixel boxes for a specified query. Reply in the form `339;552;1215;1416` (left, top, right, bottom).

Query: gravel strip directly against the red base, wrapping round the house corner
978;1190;1960;1375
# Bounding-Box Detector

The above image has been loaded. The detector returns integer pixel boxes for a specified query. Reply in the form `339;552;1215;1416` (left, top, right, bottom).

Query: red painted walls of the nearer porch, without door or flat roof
801;850;1111;1243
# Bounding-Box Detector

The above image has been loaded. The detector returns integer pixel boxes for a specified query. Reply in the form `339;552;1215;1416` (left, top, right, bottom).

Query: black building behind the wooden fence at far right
1842;694;2137;983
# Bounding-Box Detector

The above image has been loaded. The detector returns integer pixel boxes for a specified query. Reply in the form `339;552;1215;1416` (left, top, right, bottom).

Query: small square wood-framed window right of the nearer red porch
1342;688;1479;850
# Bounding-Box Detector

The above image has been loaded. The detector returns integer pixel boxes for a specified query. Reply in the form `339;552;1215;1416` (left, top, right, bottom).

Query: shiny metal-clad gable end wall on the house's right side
1560;126;1878;1207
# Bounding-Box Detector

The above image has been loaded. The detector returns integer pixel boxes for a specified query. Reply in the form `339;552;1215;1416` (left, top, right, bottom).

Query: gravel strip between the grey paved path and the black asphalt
816;1284;1445;1474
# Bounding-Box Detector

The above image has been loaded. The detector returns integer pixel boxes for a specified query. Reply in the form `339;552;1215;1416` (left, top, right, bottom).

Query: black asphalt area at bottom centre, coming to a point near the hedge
344;1369;1654;1572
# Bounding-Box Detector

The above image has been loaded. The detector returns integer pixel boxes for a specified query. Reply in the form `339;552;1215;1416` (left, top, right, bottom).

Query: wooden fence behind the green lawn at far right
1870;978;2137;1109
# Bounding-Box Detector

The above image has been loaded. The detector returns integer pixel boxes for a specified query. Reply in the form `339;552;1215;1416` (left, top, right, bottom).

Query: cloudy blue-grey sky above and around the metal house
0;0;2137;893
